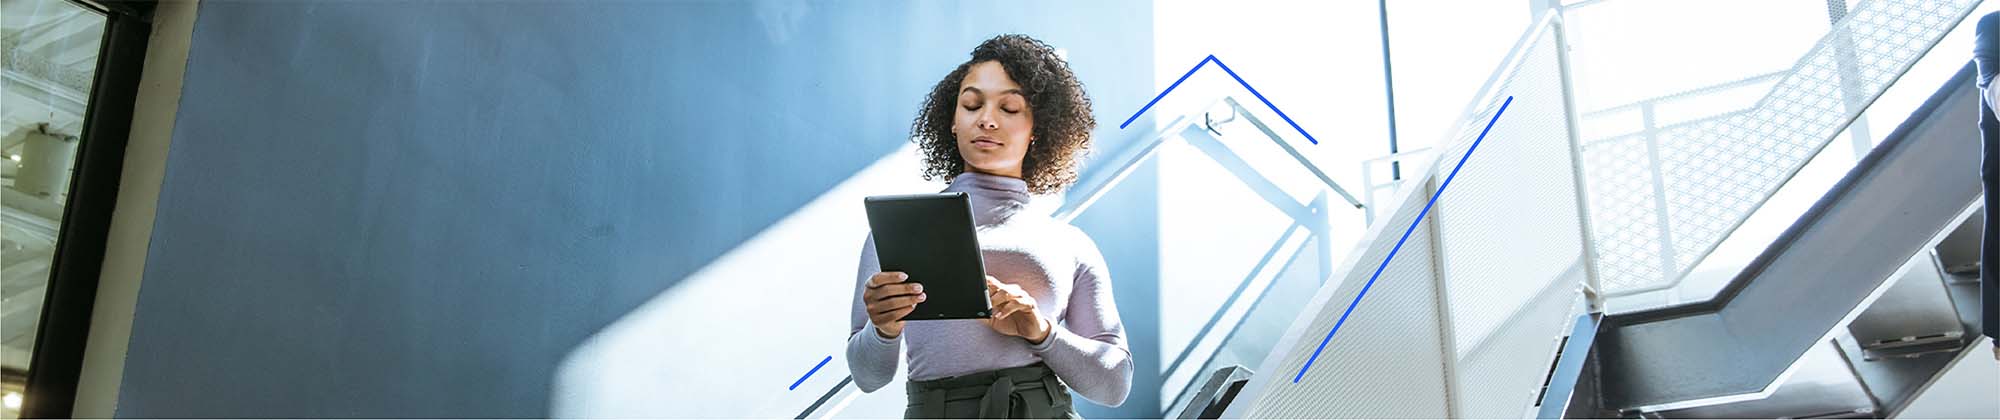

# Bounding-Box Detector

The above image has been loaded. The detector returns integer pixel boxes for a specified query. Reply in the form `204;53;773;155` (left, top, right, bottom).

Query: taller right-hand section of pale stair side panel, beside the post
1432;26;1584;418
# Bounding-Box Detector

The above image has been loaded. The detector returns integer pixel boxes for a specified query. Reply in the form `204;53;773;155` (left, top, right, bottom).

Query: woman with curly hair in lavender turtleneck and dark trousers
848;34;1132;418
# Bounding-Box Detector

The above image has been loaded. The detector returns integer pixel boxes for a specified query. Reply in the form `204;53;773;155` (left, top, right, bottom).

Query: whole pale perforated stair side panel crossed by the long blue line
1242;18;1588;418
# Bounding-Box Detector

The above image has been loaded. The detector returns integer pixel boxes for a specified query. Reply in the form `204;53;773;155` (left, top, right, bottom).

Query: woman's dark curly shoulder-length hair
910;34;1098;194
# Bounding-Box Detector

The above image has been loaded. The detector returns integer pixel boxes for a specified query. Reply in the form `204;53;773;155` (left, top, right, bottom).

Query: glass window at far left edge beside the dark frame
0;0;106;418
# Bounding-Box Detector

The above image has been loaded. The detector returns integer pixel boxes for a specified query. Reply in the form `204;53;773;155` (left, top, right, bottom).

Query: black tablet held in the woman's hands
864;192;992;320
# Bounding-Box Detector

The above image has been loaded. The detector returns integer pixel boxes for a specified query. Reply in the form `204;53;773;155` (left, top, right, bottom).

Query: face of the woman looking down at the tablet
952;62;1034;178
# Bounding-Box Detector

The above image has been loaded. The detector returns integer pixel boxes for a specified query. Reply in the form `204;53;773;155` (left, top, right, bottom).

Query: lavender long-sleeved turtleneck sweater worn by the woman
848;172;1132;406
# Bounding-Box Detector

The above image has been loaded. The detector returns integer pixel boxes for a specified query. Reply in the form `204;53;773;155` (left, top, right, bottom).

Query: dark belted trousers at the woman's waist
902;362;1080;418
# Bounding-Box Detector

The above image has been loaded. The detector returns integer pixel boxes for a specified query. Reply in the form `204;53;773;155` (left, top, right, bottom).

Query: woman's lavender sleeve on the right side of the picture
1028;232;1132;406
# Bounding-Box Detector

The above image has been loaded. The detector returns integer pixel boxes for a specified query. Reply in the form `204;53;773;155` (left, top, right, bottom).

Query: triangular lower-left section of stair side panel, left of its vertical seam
1246;188;1446;418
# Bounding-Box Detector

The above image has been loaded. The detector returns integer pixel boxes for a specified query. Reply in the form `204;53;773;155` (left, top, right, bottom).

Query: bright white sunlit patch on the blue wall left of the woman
552;146;936;418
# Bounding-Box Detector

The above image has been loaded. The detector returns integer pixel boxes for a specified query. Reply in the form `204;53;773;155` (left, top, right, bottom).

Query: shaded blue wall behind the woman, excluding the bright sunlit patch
118;0;1158;418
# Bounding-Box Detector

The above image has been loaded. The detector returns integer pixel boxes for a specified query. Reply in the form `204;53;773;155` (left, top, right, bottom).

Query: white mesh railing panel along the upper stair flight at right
1584;0;1978;294
